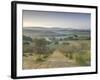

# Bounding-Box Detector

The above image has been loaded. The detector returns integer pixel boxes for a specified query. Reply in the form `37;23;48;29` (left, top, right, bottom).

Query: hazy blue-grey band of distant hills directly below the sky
23;27;90;38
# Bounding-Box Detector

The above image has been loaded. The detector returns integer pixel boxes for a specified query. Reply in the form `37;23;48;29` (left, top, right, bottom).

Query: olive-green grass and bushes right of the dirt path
59;40;91;66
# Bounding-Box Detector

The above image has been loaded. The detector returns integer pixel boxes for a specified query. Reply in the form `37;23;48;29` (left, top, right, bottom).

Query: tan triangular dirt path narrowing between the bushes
37;51;74;68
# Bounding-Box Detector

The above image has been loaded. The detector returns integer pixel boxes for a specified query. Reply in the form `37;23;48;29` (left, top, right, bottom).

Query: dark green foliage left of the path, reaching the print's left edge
23;38;54;61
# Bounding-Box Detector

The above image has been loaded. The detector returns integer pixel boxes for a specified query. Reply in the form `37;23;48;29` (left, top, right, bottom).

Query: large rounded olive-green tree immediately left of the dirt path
33;38;54;61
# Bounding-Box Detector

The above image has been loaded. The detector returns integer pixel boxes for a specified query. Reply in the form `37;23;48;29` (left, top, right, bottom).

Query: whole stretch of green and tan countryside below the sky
22;28;91;69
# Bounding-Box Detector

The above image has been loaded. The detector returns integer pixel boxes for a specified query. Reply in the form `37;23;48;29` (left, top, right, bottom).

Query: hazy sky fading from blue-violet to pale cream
23;10;91;29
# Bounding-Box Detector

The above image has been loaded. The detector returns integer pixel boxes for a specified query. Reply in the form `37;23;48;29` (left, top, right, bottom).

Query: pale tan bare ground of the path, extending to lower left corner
23;51;75;69
